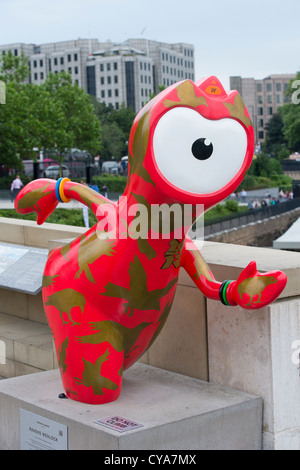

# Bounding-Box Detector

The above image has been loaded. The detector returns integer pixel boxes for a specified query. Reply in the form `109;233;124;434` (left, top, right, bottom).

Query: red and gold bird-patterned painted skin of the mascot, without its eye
15;77;286;404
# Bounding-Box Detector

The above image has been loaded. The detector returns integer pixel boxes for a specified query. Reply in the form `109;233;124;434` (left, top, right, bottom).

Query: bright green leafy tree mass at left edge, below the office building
0;65;101;173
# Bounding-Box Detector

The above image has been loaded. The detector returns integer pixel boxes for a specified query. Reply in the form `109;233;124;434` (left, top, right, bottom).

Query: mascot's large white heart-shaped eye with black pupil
153;107;247;194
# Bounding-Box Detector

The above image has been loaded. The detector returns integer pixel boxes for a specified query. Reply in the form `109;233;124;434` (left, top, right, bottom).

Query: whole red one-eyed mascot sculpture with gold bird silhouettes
15;77;286;404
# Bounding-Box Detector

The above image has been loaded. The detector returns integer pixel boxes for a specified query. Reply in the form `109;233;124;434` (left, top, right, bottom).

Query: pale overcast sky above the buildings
0;0;300;88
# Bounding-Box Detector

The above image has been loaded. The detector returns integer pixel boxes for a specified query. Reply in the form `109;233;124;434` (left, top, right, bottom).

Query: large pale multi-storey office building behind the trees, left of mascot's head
0;39;194;112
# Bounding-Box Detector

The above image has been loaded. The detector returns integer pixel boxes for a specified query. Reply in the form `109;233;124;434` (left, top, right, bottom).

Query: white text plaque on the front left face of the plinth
20;408;68;450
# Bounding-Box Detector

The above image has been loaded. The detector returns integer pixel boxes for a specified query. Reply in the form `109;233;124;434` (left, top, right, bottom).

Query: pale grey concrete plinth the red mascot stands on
0;364;262;450
